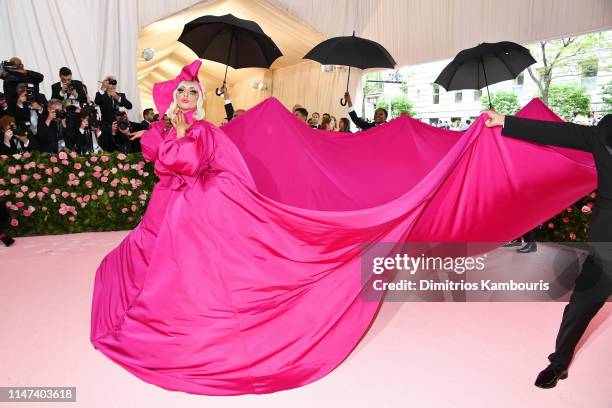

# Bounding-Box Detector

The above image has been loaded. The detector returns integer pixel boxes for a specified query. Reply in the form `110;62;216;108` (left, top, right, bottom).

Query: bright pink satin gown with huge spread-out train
91;99;596;395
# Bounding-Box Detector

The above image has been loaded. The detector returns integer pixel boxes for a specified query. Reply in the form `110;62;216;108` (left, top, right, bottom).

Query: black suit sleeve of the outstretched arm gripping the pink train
502;116;597;152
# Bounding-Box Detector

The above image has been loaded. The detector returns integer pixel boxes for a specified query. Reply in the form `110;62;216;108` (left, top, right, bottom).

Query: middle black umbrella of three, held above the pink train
304;31;396;106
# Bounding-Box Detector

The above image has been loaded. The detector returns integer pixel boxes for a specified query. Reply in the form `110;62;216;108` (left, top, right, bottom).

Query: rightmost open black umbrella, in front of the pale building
434;41;536;108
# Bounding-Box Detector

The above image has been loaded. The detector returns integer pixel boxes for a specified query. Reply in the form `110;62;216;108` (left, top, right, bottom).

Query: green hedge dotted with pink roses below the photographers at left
0;152;156;236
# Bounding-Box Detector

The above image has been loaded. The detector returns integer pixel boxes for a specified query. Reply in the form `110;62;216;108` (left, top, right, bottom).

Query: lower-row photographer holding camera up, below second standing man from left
34;99;66;153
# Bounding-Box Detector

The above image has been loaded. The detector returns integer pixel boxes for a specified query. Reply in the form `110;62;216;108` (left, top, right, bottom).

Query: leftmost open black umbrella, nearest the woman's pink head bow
178;14;283;95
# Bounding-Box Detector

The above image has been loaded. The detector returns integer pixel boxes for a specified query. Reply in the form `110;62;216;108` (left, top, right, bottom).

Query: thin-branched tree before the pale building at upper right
527;33;609;105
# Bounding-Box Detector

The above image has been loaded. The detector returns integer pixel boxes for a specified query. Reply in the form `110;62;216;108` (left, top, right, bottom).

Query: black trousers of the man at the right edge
548;198;612;369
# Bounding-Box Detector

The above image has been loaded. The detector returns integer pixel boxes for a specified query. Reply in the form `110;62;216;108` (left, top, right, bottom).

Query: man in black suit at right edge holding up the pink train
485;110;612;388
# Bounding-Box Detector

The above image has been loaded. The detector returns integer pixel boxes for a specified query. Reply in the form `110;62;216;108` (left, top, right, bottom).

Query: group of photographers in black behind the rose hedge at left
0;57;158;154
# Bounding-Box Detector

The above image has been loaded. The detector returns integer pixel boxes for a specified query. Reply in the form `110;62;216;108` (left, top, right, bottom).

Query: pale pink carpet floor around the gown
0;232;612;408
